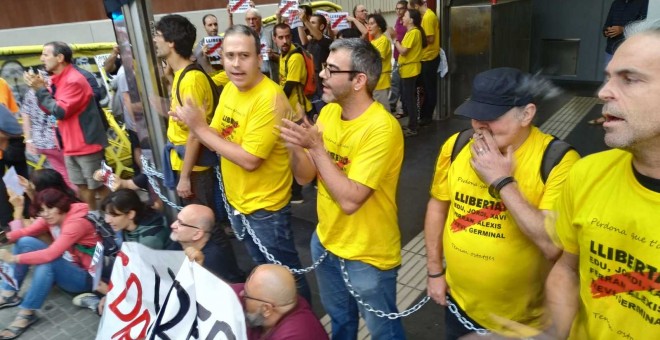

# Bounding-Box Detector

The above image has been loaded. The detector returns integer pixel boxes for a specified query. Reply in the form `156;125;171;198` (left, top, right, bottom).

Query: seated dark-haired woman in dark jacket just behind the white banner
73;189;170;314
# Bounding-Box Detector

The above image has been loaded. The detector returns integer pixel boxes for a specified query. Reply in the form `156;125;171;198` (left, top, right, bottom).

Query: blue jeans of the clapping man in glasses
310;232;406;340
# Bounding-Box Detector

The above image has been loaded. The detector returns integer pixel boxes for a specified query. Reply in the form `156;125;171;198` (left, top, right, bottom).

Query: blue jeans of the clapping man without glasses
229;204;312;305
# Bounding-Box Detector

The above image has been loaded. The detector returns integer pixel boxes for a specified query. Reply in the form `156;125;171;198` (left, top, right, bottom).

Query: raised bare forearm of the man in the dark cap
500;183;561;261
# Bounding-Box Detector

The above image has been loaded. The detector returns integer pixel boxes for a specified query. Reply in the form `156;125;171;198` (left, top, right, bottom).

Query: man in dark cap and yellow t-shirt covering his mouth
424;68;579;339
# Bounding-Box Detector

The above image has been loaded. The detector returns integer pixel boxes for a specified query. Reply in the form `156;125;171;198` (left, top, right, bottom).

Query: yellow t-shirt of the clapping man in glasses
316;102;403;270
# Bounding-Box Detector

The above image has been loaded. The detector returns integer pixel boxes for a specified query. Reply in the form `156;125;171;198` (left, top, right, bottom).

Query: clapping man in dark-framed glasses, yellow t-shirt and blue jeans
281;39;405;339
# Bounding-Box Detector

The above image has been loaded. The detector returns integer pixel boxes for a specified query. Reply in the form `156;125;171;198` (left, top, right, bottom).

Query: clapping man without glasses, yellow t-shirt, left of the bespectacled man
175;25;311;301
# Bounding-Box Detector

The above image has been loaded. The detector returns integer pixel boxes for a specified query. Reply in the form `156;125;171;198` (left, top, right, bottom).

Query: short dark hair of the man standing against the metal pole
156;14;197;58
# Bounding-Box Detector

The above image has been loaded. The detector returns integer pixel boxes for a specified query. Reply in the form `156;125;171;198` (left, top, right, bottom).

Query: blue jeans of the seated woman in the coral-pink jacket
2;236;92;310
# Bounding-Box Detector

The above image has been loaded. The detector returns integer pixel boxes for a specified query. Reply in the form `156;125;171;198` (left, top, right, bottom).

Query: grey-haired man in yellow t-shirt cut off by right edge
546;21;660;339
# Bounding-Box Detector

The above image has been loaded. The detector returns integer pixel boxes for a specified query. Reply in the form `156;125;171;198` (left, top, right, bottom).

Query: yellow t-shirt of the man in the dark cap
431;127;579;333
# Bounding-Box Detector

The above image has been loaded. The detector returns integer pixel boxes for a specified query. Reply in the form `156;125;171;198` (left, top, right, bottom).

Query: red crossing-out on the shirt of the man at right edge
591;272;660;299
